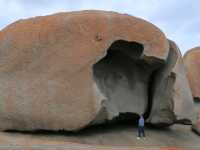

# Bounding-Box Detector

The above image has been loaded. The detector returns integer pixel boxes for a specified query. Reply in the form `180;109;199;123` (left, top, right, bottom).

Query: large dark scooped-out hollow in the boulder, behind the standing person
92;40;163;124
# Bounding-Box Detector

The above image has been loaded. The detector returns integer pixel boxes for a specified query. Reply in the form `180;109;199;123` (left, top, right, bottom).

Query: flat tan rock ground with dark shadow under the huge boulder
0;124;200;150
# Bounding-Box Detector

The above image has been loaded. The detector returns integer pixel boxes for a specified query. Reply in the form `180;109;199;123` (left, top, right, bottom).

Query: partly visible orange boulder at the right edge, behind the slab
184;47;200;135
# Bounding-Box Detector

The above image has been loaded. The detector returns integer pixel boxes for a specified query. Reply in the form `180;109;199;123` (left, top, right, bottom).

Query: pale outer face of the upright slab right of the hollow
170;41;195;124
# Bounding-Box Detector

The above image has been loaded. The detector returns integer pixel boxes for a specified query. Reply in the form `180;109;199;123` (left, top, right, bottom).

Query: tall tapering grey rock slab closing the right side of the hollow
148;40;195;125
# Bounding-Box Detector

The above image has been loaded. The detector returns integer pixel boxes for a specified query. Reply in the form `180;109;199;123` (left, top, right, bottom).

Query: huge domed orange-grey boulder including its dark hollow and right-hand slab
0;11;193;130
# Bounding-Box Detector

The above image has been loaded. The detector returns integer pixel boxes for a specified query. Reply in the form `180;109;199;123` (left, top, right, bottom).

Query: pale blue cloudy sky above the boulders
0;0;200;53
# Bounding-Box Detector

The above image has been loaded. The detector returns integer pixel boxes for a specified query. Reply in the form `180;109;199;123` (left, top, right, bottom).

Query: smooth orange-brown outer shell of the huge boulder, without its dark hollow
0;11;168;130
